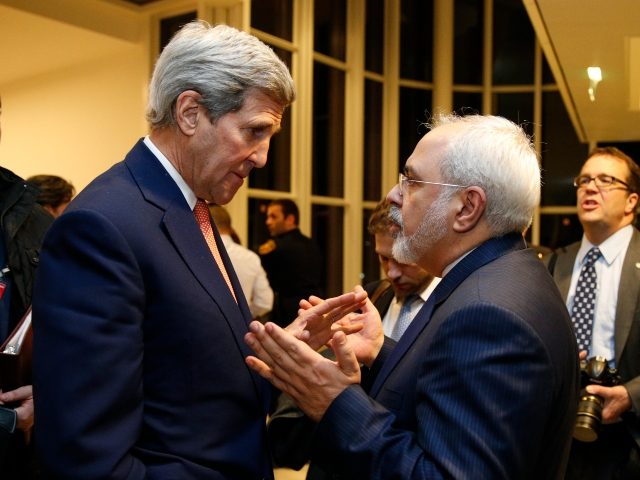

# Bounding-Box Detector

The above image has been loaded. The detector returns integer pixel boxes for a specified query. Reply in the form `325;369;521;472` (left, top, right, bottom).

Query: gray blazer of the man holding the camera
549;228;640;441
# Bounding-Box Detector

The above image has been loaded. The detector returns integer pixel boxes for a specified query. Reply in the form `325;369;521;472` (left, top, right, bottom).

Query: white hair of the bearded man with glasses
429;115;540;236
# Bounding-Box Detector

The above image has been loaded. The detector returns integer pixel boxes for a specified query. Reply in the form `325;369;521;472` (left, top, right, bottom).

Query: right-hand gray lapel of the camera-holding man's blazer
614;228;640;362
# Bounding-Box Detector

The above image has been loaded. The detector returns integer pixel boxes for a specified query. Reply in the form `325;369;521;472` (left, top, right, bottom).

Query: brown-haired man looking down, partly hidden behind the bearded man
268;199;440;480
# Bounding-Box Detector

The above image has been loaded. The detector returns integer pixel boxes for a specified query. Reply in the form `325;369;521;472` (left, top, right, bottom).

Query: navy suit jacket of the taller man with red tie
33;141;273;480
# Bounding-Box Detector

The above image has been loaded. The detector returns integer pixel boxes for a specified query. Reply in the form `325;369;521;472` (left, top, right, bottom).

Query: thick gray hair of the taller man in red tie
147;20;296;129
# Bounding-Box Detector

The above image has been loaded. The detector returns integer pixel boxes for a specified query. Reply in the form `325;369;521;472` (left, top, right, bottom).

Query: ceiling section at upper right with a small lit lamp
523;0;640;142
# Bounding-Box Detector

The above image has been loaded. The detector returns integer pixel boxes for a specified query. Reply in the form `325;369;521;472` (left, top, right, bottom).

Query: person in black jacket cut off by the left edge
0;94;53;479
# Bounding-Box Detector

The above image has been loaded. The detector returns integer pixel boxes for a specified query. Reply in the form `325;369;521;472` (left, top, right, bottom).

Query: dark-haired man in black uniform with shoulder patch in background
258;199;324;327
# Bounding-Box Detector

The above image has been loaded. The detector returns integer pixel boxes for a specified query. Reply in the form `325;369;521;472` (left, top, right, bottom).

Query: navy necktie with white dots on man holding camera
571;247;602;351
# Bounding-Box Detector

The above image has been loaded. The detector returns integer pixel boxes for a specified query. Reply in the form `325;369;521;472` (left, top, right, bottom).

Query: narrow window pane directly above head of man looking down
363;80;382;201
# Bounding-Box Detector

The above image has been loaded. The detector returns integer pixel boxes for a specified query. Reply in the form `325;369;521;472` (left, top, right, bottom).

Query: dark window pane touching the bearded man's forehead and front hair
398;88;431;171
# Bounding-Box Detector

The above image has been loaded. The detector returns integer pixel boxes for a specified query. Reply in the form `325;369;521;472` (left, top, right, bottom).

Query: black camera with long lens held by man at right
573;357;621;442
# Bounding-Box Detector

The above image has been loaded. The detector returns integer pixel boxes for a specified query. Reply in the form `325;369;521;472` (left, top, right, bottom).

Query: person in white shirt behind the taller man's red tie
209;205;273;318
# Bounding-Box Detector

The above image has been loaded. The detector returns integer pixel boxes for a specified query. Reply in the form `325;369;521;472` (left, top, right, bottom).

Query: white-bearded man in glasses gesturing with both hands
245;116;578;480
